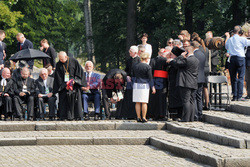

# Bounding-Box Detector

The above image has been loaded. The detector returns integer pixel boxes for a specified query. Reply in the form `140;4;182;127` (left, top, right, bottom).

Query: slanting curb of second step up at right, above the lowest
166;122;247;148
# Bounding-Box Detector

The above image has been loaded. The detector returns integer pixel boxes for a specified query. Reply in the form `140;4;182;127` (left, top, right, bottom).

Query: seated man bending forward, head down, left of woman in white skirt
102;69;127;119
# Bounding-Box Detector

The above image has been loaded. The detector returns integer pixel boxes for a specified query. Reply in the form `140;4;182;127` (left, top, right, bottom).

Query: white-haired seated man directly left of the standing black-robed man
35;68;56;121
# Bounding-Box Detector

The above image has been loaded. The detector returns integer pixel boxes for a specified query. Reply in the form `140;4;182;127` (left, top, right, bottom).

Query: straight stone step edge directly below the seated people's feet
0;120;166;132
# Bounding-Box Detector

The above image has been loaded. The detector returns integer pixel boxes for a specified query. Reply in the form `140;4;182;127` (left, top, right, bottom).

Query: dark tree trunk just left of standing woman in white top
126;0;136;58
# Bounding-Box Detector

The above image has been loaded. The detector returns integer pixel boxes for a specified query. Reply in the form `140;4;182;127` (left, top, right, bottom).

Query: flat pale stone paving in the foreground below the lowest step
0;145;204;167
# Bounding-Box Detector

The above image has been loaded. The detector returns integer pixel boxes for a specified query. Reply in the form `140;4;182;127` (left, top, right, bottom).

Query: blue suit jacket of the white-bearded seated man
83;72;101;93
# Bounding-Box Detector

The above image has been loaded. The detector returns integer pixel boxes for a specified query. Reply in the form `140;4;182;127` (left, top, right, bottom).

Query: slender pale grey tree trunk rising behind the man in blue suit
84;0;96;64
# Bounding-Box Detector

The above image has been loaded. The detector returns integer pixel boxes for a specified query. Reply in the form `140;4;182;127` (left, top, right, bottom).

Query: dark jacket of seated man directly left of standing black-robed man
35;77;54;95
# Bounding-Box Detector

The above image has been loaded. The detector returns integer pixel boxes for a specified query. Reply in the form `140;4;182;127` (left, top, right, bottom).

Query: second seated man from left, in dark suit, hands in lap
13;67;35;121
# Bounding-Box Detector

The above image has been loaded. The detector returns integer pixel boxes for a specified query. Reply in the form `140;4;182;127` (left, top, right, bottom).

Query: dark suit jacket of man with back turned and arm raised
171;55;199;89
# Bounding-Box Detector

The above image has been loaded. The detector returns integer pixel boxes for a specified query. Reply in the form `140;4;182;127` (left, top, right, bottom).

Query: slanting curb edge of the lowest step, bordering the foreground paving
149;137;224;167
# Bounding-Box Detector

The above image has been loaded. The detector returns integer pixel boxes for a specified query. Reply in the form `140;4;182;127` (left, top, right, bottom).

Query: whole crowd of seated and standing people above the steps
0;26;250;123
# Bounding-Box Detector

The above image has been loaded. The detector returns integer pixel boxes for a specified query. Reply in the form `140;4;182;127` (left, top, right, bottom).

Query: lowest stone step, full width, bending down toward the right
0;130;250;167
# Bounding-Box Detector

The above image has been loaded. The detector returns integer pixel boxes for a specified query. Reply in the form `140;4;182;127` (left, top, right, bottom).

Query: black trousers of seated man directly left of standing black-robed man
37;96;56;118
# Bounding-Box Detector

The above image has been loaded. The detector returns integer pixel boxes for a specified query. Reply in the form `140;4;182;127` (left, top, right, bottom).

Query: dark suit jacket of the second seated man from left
14;77;36;96
